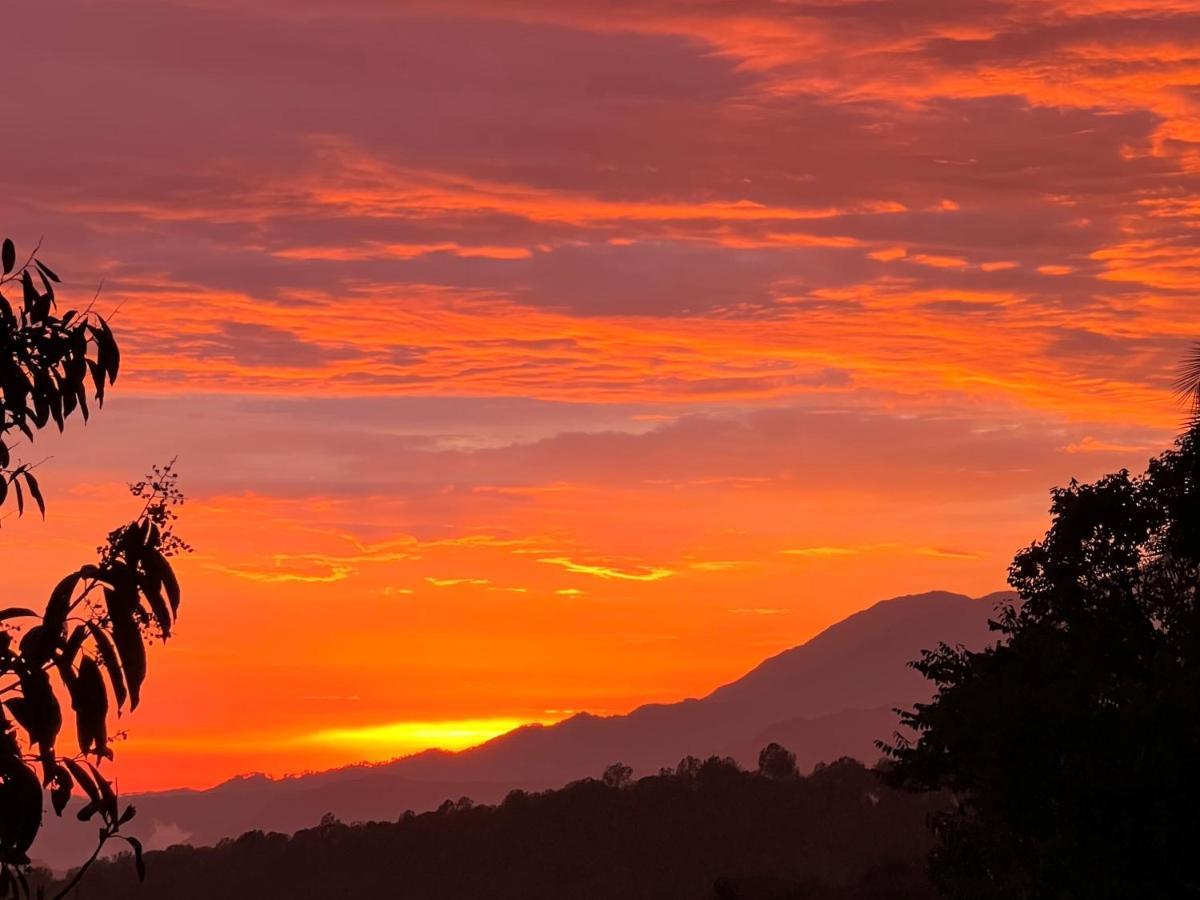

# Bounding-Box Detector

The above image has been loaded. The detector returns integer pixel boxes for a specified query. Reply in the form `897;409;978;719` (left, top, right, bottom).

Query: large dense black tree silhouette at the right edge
884;430;1200;899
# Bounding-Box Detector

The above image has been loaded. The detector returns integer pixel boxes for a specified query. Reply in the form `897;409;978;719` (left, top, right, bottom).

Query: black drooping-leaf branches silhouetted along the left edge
0;240;187;898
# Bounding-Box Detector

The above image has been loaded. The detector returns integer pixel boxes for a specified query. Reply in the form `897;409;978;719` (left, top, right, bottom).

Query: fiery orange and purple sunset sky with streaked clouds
0;0;1200;791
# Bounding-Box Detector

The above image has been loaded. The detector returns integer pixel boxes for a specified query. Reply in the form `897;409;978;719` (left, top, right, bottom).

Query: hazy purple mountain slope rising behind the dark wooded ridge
32;592;1010;869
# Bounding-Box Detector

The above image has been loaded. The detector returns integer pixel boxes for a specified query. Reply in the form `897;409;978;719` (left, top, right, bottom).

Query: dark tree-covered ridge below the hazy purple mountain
44;757;938;900
